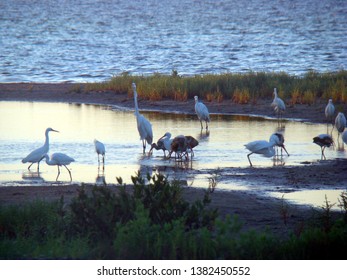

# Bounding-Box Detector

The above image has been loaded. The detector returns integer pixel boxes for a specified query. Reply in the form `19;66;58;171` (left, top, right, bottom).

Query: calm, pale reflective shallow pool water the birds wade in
0;101;347;209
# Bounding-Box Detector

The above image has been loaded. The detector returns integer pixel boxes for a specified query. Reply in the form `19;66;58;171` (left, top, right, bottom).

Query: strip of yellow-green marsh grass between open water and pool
85;70;347;104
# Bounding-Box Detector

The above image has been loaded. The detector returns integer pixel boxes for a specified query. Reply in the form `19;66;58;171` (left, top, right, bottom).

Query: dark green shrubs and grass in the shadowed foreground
0;174;347;259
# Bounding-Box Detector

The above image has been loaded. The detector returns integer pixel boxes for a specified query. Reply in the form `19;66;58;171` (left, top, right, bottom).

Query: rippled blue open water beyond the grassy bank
0;0;347;82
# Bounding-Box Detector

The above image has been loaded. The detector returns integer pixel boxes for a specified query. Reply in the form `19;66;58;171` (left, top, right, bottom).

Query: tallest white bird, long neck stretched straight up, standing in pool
132;83;153;153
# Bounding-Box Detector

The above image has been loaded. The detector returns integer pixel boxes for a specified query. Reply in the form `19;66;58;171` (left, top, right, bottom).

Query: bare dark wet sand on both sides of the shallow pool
0;83;347;235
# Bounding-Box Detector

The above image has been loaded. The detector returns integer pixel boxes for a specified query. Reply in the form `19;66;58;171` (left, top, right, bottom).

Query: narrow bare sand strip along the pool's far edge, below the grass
0;83;347;123
